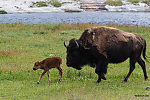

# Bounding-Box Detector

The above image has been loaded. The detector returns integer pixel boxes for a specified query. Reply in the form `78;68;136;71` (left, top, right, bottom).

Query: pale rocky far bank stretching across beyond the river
0;0;150;13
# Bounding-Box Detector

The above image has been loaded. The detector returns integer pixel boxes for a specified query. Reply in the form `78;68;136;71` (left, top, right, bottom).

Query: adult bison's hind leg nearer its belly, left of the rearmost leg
124;58;136;82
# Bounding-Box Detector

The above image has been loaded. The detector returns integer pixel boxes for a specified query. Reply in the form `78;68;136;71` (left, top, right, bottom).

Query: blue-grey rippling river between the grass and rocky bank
0;11;150;26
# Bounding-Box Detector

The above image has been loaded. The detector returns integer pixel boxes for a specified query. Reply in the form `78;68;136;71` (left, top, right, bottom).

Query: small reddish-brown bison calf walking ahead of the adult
33;57;62;84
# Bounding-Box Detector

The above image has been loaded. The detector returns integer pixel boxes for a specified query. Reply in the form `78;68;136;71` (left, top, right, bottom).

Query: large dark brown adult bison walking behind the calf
64;27;148;83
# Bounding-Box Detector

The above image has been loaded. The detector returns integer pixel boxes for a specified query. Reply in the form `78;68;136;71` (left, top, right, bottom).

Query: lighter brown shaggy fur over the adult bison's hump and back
79;27;132;58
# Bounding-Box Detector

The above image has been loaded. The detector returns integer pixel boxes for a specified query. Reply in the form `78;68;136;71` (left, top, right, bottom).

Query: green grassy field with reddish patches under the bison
0;24;150;100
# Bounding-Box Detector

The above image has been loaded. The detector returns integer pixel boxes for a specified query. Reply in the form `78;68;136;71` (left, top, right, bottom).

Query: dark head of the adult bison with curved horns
64;39;85;70
